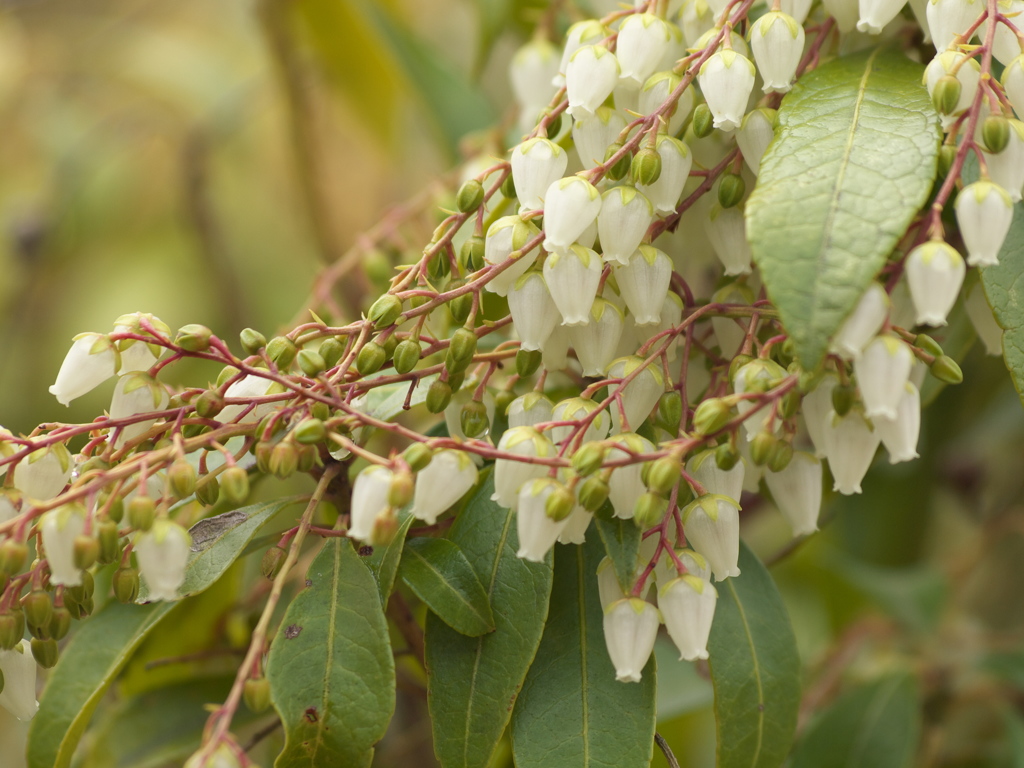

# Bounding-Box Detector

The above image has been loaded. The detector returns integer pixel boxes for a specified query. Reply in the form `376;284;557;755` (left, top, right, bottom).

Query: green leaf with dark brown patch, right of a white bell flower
137;497;299;603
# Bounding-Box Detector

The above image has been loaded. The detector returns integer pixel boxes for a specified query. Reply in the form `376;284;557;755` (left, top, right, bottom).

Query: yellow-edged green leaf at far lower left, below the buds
28;602;175;768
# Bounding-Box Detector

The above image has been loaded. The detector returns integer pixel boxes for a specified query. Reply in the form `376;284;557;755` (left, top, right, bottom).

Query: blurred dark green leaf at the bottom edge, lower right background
793;675;921;768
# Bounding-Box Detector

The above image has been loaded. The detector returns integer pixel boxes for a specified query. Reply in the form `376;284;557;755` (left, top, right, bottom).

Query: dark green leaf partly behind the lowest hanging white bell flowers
511;537;656;768
